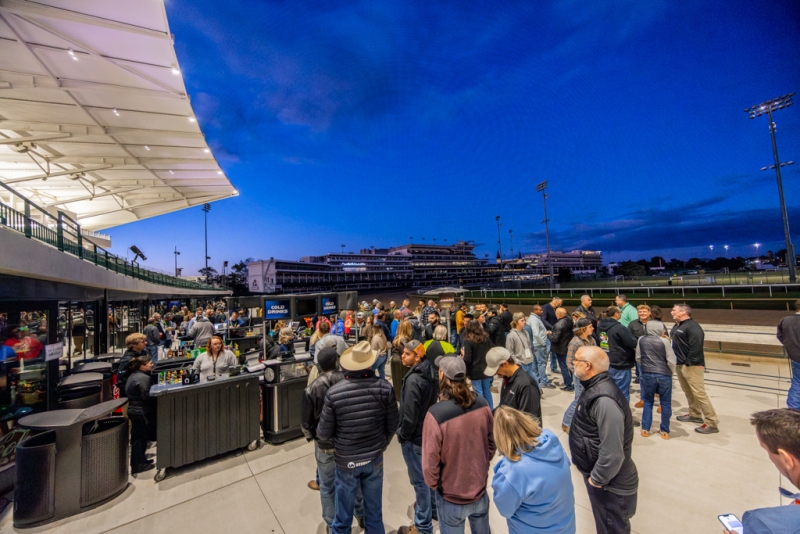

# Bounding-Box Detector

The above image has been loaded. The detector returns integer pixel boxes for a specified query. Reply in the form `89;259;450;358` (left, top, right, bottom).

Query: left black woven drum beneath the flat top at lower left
14;430;56;527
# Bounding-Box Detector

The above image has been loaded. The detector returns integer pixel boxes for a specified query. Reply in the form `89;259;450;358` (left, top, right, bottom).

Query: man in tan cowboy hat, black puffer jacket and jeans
317;341;398;534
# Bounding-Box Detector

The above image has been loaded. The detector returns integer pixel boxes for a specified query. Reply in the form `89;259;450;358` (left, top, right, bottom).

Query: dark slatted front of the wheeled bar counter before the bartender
150;374;260;482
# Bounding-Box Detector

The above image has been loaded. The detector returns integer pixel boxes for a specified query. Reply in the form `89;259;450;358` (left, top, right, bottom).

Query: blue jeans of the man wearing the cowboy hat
331;454;386;534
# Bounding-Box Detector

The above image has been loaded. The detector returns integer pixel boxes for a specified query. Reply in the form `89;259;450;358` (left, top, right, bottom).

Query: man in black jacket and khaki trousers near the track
670;304;719;434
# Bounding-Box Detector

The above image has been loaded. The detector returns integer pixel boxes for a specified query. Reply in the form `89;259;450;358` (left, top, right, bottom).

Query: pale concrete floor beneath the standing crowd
0;356;792;534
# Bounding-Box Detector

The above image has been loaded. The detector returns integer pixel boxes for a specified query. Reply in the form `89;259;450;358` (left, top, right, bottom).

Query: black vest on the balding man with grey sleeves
569;372;638;487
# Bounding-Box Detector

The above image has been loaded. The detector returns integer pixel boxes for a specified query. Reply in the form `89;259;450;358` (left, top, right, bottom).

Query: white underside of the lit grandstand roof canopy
0;0;237;230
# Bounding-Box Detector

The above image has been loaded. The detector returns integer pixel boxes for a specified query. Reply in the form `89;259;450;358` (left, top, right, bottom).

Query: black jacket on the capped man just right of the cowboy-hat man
397;358;437;447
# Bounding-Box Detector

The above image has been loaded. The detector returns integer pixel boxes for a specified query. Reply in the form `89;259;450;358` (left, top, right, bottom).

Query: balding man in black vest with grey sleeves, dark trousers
569;347;639;534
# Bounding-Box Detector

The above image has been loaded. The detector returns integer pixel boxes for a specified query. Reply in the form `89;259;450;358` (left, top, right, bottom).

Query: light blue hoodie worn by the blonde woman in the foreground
492;430;575;534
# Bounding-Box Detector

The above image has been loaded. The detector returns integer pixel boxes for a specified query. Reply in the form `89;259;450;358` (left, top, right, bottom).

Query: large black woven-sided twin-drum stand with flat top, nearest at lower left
14;400;128;527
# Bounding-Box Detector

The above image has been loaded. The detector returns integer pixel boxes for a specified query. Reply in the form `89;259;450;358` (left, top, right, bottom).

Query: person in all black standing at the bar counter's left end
125;355;156;475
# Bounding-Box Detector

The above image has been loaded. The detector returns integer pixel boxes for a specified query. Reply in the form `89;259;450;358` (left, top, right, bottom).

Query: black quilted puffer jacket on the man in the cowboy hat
317;369;398;469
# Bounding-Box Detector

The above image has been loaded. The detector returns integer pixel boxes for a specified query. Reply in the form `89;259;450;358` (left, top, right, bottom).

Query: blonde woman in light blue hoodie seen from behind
492;406;575;534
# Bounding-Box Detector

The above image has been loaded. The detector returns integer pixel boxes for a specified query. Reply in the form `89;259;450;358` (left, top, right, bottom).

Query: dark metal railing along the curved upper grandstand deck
0;182;224;291
